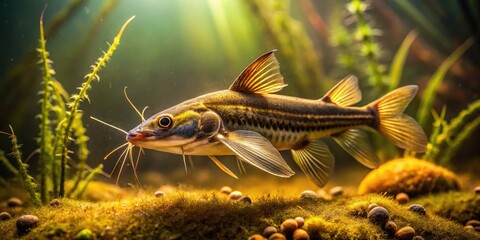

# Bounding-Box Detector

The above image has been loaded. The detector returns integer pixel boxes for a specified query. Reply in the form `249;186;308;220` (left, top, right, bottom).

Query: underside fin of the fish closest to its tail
332;129;380;168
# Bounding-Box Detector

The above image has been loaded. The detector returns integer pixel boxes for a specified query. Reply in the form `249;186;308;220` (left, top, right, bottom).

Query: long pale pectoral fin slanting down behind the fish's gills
217;130;295;177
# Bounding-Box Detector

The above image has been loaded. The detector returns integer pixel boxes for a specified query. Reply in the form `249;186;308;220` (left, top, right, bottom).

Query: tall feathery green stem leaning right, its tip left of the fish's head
59;16;135;197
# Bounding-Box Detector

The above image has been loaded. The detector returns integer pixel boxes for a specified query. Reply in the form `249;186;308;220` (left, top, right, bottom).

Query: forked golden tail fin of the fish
367;85;428;152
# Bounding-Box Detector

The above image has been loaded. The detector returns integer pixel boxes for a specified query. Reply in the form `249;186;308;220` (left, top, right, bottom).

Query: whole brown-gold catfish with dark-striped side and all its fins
127;52;427;186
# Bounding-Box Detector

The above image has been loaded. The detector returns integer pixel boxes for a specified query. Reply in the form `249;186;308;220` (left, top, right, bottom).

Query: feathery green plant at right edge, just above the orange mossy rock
423;100;480;165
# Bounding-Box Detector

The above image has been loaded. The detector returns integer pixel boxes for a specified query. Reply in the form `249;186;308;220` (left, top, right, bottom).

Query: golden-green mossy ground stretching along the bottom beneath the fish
0;190;480;239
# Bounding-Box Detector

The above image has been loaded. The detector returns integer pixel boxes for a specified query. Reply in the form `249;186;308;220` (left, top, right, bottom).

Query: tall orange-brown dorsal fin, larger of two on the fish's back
229;50;287;94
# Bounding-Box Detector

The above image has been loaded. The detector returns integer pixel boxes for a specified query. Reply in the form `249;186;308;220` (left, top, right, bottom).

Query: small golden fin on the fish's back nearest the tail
320;75;362;107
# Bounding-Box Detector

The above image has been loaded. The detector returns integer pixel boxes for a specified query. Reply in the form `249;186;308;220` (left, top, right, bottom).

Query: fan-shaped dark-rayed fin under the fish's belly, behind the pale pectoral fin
292;141;335;187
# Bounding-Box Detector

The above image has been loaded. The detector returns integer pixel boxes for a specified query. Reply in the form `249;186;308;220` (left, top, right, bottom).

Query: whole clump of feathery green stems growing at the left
0;13;134;205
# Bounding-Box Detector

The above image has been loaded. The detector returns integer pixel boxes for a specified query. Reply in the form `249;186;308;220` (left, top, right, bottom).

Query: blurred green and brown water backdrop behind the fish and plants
0;0;480;188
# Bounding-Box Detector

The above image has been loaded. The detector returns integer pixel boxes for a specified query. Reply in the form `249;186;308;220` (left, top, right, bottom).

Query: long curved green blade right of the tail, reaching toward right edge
417;38;475;128
